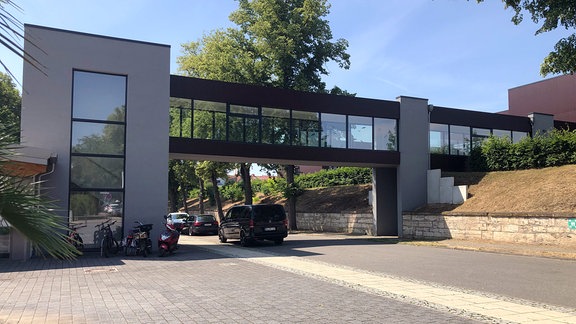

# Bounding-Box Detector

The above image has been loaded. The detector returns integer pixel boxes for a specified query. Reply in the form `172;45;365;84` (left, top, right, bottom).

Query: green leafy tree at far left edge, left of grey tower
0;72;22;142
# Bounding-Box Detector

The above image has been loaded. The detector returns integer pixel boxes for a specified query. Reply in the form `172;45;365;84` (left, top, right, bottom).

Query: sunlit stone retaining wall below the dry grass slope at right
402;213;576;247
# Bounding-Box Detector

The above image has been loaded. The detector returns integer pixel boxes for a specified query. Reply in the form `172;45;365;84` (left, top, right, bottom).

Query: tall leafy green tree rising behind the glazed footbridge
178;0;350;229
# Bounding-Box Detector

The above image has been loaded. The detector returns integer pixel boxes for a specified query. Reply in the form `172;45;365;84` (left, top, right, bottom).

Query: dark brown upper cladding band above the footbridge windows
170;75;400;119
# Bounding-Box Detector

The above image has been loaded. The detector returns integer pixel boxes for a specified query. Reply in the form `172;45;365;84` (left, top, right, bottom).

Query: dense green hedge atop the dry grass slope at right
470;130;576;171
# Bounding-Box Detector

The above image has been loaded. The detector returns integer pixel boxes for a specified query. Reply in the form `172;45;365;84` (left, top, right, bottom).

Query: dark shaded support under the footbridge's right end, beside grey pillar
372;168;399;236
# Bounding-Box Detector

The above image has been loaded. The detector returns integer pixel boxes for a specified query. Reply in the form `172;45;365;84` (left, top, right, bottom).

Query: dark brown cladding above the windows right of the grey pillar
430;107;532;133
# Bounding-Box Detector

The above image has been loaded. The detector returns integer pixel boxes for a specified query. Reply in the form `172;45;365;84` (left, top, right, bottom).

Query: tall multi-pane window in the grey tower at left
69;71;126;247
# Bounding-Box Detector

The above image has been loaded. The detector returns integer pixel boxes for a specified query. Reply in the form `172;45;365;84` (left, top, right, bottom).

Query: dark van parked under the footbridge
218;205;288;246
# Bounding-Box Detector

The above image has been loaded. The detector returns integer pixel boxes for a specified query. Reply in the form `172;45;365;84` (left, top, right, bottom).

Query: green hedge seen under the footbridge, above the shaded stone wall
295;167;372;189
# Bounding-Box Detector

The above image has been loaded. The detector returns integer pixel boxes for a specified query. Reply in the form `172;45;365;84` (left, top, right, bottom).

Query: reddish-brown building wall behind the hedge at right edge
505;75;576;122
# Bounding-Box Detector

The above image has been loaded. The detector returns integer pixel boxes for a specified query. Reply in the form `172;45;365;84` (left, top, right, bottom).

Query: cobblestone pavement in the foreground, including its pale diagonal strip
0;237;576;323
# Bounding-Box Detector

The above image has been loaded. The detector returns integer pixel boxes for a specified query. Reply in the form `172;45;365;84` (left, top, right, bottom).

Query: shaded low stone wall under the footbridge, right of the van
296;213;374;235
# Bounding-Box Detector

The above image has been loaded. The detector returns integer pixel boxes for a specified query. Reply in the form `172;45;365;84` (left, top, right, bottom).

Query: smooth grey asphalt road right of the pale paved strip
245;235;576;308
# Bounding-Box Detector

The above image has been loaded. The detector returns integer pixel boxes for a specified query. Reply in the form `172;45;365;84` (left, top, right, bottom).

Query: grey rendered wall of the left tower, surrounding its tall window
21;25;170;247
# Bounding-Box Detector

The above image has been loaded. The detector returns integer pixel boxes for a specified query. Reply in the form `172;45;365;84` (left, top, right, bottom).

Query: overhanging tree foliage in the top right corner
478;0;576;76
